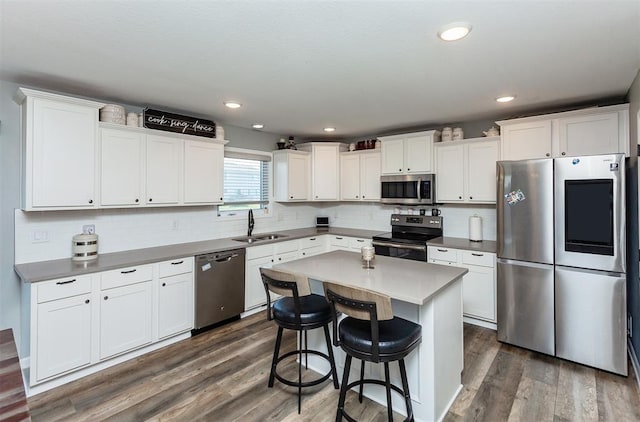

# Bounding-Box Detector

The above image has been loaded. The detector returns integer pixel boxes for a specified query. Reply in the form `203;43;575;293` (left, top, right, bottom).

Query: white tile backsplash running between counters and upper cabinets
15;202;496;264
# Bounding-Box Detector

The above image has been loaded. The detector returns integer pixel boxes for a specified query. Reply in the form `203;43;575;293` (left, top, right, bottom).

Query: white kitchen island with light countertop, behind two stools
273;251;467;421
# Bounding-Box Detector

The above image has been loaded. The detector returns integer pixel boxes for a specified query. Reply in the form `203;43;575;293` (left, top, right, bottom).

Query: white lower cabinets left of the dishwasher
23;257;194;386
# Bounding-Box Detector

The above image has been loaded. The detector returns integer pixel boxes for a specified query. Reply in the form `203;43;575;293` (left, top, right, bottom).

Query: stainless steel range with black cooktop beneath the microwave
372;214;442;261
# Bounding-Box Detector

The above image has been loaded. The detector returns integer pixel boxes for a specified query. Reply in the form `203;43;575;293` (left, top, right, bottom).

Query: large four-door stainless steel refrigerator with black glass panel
497;154;627;375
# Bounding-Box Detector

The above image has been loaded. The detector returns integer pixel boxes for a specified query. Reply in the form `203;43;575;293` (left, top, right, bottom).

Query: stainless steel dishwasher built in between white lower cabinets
194;249;245;330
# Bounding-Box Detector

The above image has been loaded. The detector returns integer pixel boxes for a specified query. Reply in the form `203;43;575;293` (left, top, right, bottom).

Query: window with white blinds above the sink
218;148;271;214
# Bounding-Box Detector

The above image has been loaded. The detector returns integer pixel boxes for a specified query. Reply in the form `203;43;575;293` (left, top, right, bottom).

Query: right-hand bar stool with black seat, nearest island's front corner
324;282;422;422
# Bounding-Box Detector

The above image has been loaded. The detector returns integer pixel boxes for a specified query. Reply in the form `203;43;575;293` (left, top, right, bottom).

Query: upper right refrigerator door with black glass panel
554;154;625;273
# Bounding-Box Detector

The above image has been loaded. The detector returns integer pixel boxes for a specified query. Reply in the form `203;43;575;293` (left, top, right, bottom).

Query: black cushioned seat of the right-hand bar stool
339;317;422;362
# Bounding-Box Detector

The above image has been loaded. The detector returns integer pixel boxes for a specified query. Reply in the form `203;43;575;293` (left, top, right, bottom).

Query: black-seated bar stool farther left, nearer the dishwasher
260;268;338;413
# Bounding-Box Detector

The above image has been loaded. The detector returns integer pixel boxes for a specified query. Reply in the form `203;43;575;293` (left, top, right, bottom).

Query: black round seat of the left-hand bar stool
273;294;331;328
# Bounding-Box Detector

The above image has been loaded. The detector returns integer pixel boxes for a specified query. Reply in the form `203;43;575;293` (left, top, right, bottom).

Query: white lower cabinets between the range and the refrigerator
428;246;496;323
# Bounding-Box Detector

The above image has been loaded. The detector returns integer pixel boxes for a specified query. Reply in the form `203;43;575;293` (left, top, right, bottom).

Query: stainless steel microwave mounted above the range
380;174;436;205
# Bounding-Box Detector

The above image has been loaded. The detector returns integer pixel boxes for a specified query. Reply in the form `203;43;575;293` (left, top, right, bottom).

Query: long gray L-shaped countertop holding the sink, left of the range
14;227;380;283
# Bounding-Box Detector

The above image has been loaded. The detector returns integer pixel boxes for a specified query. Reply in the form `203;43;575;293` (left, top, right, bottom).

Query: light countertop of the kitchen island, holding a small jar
273;251;468;305
